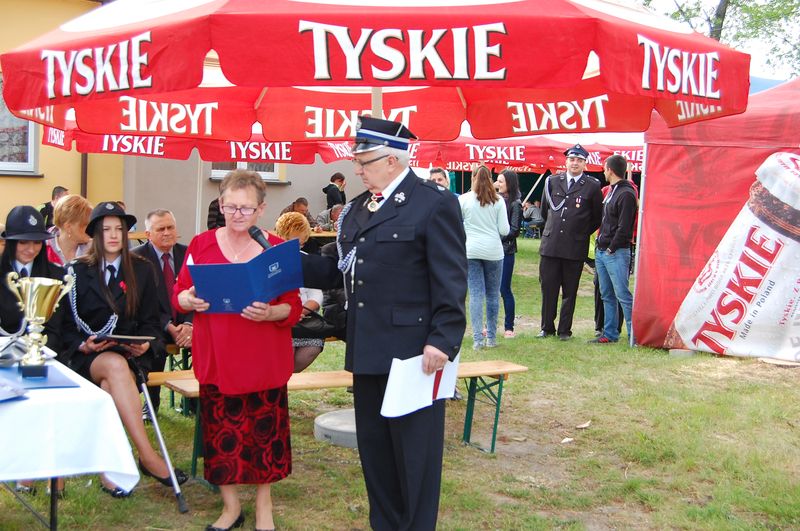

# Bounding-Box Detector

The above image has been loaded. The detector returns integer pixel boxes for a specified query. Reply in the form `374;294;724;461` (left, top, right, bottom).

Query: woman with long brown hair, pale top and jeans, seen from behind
458;166;509;350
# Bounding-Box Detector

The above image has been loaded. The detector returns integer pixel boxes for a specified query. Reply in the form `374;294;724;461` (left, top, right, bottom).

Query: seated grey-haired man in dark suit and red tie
133;209;193;420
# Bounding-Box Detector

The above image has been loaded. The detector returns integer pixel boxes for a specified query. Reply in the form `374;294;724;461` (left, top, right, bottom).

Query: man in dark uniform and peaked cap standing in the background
539;144;603;341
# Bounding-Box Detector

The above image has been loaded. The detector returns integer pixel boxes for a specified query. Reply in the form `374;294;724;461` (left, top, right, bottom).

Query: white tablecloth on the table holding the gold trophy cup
0;360;139;491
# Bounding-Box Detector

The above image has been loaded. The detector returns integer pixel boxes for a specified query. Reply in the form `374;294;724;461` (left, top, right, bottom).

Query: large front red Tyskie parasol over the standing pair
0;0;749;141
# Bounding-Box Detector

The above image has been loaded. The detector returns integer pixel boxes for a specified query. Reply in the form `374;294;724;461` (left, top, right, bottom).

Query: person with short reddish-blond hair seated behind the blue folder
275;212;325;372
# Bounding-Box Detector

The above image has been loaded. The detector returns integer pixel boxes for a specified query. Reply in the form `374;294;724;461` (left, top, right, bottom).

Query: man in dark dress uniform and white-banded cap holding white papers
303;117;467;530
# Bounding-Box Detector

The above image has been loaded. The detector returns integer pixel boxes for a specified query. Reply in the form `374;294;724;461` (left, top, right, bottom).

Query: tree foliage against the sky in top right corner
641;0;800;76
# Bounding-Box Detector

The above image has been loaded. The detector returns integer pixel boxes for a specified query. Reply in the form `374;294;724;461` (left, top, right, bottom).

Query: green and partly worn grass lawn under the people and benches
0;240;800;530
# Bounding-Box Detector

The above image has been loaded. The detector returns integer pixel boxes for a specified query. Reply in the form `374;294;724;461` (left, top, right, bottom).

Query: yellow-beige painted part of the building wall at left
0;0;122;222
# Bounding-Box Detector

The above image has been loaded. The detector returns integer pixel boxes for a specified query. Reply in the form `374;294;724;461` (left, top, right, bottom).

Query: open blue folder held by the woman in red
189;240;303;313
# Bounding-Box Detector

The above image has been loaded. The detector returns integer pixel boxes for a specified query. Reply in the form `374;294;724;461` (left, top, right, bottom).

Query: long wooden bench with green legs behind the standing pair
152;360;528;477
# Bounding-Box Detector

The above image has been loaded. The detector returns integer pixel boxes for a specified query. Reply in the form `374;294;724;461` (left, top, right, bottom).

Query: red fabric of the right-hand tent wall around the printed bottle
633;79;800;361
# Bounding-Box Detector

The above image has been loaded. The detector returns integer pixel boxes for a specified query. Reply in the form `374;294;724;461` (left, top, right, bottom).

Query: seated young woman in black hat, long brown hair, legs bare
63;202;188;498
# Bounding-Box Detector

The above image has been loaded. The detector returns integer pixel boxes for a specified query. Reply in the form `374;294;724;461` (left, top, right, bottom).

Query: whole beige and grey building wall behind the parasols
0;0;364;234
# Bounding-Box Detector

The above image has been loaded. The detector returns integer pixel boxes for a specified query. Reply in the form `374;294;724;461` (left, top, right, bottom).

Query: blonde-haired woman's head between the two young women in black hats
47;194;92;265
